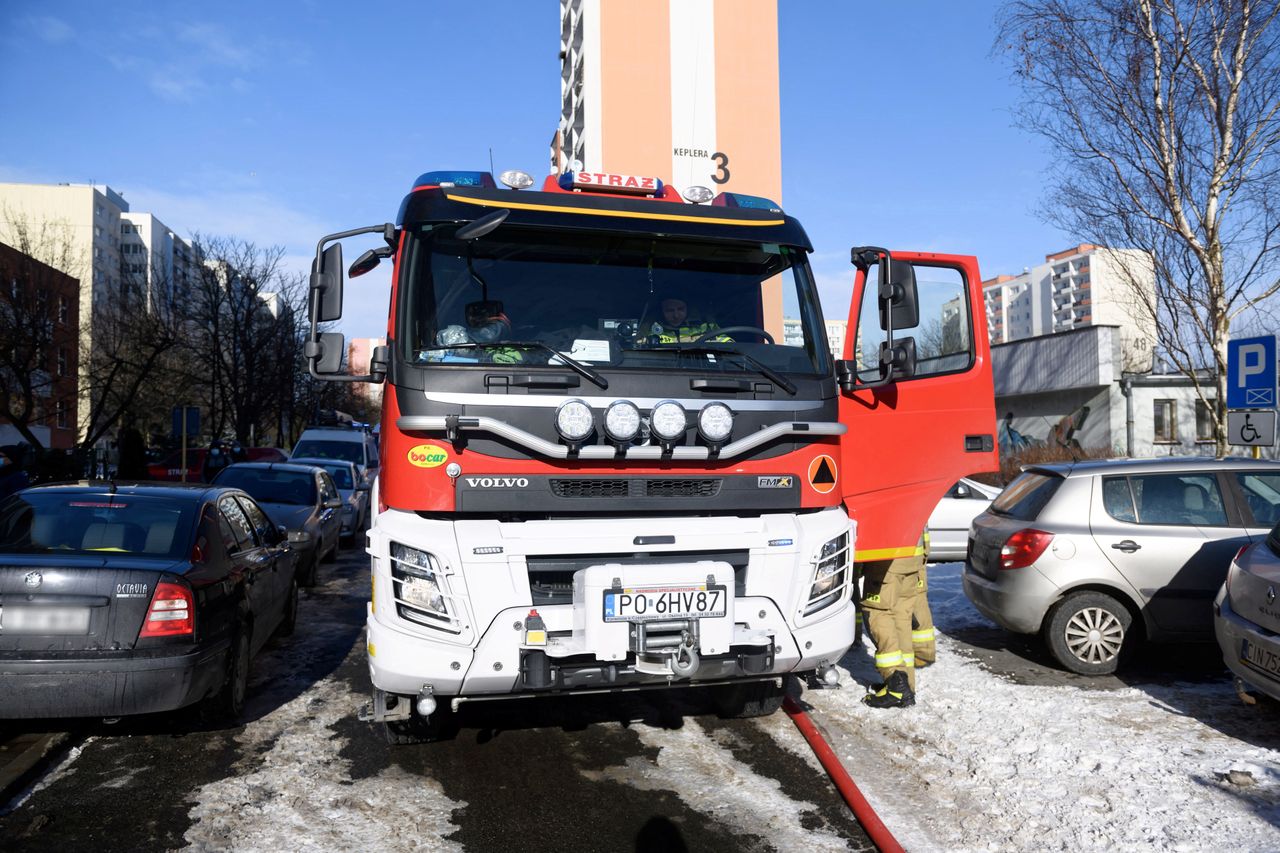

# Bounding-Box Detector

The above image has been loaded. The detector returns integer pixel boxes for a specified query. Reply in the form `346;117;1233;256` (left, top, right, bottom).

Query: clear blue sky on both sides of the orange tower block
0;0;1078;337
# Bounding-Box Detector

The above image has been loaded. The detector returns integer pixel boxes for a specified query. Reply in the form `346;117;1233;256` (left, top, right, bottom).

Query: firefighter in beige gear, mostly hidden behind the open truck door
861;535;933;708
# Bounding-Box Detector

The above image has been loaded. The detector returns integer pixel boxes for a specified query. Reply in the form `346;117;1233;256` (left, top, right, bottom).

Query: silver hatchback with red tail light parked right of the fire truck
964;457;1280;675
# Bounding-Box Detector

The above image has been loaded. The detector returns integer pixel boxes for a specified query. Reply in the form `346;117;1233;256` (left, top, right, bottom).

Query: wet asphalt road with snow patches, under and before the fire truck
0;537;870;852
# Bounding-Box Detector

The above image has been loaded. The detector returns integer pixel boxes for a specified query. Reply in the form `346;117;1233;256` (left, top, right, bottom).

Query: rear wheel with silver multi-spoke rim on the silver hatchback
1044;592;1133;675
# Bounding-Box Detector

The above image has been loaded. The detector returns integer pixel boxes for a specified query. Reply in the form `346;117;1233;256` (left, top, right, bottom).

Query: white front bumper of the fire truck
367;510;854;695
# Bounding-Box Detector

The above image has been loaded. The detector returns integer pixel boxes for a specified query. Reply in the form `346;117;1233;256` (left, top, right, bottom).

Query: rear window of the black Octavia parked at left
0;491;197;560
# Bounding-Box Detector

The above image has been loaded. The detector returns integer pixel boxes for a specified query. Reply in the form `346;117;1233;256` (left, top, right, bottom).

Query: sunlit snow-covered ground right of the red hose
804;564;1280;850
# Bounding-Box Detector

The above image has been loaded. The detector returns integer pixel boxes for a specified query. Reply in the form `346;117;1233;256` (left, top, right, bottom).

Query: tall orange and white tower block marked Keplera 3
552;0;782;334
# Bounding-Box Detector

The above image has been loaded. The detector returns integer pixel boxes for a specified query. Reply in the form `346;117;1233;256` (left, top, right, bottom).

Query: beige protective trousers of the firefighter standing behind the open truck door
863;555;924;690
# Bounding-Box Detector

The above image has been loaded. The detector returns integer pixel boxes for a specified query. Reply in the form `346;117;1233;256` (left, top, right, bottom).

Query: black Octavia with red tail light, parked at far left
0;483;298;719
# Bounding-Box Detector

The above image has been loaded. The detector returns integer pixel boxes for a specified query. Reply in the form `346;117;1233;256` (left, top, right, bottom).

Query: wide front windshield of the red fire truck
399;224;831;375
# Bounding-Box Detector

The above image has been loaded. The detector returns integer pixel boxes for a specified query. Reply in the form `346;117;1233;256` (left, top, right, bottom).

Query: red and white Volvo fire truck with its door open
306;166;996;742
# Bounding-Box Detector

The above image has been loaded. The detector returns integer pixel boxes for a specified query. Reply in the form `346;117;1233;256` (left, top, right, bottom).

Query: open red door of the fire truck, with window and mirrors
836;247;998;562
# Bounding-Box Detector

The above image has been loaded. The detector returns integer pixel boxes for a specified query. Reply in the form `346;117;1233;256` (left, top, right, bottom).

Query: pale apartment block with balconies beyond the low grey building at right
983;243;1156;371
